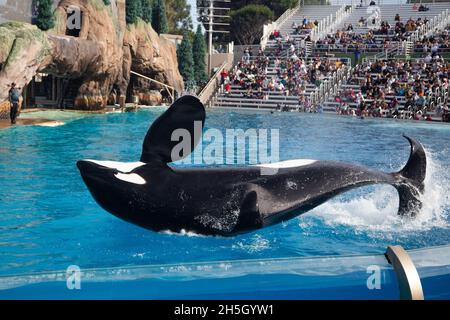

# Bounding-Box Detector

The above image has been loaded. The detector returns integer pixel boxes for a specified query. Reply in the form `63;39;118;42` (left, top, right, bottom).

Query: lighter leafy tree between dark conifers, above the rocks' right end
165;0;193;34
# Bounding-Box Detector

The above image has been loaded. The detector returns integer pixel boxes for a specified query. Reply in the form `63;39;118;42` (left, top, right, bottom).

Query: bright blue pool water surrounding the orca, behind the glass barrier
0;108;450;290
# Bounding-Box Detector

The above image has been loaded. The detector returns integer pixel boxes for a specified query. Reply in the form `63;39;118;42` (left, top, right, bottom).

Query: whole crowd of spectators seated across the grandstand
221;7;450;120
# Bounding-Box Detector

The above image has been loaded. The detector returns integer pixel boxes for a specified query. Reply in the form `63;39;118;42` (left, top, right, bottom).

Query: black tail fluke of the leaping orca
393;135;427;217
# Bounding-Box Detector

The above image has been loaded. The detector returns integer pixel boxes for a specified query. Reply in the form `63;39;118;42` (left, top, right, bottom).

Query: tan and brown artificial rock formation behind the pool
0;0;184;110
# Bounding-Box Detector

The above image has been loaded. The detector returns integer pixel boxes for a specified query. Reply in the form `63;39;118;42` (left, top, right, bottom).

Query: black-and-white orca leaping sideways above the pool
77;96;426;236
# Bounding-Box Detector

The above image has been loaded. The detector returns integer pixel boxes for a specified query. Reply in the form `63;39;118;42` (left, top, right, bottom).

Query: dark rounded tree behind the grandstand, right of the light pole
230;4;274;45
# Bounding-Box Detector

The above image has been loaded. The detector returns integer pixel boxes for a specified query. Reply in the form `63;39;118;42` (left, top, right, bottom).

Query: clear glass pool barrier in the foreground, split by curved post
0;246;450;299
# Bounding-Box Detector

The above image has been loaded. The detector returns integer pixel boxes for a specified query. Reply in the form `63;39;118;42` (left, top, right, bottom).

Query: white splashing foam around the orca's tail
311;152;450;233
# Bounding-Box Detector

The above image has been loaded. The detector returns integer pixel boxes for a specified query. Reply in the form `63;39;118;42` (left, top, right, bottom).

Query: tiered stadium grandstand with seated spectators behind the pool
213;3;450;120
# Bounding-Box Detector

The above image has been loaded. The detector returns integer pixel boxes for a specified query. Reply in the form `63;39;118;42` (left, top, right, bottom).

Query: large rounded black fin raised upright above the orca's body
141;95;205;163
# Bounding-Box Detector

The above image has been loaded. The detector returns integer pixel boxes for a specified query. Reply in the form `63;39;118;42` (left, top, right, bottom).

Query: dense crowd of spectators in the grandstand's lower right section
335;54;450;120
